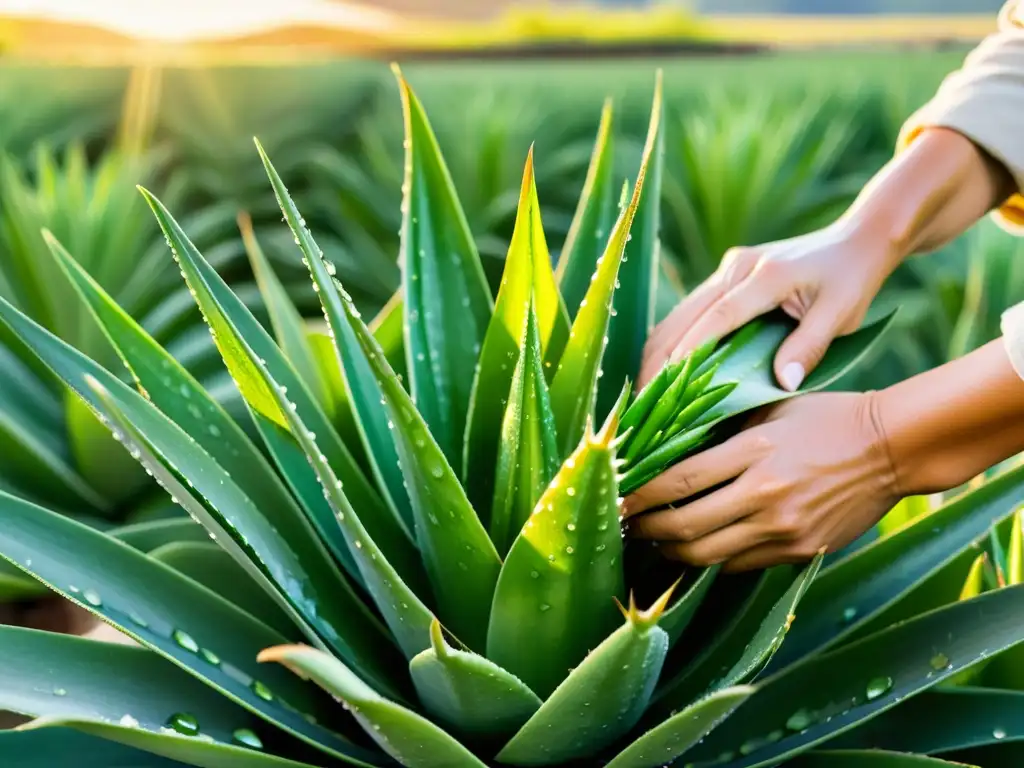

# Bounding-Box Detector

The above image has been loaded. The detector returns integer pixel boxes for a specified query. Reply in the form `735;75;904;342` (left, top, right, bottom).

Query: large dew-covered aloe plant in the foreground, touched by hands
0;67;1024;768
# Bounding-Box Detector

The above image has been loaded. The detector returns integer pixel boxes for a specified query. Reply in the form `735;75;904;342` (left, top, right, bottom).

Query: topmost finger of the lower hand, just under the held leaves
623;431;764;517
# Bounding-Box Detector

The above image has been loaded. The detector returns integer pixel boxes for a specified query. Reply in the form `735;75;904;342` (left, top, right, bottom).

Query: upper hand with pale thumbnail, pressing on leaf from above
637;220;899;391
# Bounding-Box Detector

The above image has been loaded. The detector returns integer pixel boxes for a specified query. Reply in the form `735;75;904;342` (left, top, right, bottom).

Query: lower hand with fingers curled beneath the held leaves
625;393;900;571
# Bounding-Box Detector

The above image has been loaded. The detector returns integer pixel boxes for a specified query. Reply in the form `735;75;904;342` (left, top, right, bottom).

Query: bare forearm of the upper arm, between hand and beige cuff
840;128;1014;270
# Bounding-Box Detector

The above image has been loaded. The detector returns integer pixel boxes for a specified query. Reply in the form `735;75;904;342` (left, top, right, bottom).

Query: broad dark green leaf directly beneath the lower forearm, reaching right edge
772;467;1024;669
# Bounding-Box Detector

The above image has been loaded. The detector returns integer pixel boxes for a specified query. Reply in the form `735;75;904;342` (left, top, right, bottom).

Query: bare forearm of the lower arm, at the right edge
873;340;1024;496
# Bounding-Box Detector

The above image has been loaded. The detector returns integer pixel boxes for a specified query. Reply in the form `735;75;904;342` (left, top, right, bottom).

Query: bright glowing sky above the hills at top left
0;0;392;42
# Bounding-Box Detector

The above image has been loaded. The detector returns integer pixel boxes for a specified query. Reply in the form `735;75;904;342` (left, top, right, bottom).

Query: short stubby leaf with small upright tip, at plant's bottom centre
409;622;541;740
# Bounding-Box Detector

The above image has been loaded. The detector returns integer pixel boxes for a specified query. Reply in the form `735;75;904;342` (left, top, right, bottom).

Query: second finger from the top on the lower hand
629;475;762;542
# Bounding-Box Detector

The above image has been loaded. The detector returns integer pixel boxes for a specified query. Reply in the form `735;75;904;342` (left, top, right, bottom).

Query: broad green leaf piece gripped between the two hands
614;311;893;494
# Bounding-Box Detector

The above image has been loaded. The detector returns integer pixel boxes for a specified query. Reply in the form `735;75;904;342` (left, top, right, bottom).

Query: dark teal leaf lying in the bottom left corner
0;726;182;768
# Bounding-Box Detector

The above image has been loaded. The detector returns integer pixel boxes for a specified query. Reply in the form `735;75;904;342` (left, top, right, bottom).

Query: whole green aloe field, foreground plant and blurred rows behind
0;51;1024;768
